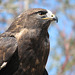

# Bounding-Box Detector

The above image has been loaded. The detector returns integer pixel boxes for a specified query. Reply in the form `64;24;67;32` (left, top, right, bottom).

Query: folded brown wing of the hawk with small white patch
0;37;17;69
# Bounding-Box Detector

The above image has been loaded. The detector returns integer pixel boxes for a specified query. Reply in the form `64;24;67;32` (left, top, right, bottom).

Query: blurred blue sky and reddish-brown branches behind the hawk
0;0;75;75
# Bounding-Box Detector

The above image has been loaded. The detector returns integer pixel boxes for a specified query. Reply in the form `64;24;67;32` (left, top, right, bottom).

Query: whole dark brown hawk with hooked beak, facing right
0;8;58;75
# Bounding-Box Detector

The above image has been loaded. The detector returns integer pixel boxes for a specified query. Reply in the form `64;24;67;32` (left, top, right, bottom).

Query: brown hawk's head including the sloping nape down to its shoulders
7;8;58;31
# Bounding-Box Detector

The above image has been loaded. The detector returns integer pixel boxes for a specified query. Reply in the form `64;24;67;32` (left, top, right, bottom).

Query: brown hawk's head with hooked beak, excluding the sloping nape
22;8;58;28
